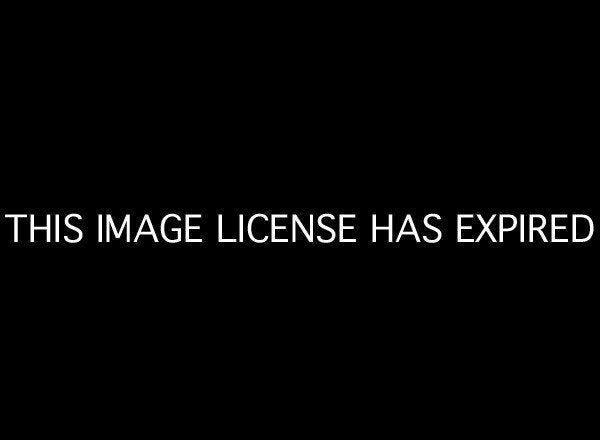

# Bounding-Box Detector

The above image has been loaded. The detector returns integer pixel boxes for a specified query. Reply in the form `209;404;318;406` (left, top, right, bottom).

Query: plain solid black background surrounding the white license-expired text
1;5;598;433
